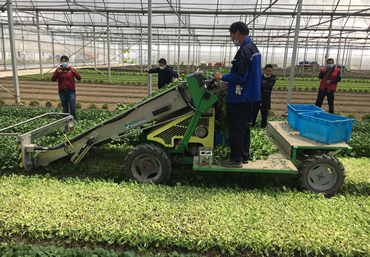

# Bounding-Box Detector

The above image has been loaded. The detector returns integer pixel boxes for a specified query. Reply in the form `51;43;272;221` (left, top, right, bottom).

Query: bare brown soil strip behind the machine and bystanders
0;77;370;119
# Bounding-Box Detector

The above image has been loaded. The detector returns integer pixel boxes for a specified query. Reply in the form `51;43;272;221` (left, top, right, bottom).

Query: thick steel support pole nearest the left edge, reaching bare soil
3;0;21;103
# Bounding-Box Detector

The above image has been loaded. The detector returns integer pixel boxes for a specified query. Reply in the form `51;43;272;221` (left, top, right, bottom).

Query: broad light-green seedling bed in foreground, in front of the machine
0;175;370;256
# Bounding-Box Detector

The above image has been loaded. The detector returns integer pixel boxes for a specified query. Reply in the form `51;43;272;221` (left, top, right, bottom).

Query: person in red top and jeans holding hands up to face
51;55;81;119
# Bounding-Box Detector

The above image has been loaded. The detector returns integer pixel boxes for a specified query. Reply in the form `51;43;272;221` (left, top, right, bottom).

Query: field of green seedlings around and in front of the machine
0;102;370;256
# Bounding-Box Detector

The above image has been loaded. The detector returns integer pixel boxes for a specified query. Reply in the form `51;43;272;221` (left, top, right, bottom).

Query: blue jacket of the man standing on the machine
222;37;261;103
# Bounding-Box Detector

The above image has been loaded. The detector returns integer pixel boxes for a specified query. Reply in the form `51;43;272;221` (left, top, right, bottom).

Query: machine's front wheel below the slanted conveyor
123;144;171;184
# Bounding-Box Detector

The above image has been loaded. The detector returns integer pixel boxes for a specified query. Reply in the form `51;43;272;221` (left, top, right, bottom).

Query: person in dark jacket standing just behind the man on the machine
251;64;276;128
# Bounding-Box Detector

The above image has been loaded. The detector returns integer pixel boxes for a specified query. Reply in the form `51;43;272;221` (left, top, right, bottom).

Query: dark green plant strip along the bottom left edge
0;243;198;257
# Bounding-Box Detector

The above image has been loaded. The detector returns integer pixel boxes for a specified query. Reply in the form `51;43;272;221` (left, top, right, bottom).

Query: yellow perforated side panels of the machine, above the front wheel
147;109;215;148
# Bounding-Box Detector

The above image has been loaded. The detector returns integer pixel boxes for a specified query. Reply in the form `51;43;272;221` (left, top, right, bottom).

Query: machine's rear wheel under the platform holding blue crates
298;154;346;196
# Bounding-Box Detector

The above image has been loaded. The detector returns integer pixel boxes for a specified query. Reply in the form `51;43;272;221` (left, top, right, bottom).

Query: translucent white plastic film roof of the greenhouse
0;0;370;49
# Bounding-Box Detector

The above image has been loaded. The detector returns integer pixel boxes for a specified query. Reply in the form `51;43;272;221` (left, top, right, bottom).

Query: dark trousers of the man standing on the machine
226;103;252;162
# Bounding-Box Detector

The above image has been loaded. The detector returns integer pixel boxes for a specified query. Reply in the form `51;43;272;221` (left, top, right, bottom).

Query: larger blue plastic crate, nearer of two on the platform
298;112;355;144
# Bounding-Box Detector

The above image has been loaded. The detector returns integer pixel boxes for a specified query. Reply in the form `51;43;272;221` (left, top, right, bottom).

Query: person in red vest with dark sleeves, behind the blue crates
315;58;342;114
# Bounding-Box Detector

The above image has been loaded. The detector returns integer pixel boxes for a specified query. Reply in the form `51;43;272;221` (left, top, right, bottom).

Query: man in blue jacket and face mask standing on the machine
213;22;261;168
